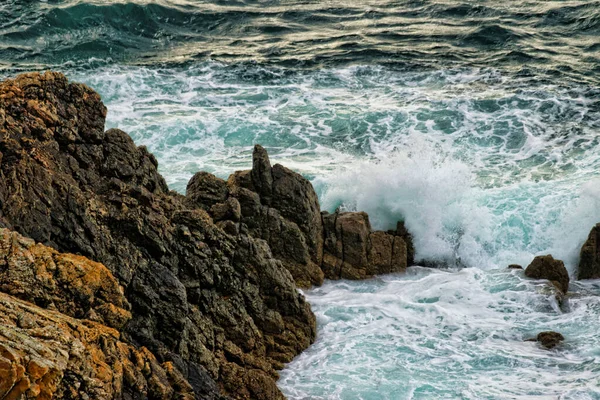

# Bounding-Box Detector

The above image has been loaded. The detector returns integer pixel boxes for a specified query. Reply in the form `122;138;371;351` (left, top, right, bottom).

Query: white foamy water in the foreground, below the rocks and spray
280;267;600;400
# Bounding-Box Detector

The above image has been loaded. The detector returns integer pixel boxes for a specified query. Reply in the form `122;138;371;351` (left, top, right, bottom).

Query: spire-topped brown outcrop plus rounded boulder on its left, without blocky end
186;145;323;287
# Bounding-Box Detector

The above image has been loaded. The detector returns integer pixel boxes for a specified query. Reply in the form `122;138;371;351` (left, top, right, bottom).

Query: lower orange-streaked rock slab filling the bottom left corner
0;293;194;400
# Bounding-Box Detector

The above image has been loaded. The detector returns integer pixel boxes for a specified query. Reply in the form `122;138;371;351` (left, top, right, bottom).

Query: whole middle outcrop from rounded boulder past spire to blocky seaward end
186;145;414;287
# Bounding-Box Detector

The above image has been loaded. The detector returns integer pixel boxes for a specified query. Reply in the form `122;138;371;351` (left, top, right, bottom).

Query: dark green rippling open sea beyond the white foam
0;0;600;82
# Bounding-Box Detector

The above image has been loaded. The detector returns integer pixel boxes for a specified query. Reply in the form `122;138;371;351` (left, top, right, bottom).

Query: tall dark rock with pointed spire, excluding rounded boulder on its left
228;145;323;287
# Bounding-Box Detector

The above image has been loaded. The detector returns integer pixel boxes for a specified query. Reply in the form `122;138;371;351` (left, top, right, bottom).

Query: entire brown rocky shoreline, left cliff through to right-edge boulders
0;72;600;400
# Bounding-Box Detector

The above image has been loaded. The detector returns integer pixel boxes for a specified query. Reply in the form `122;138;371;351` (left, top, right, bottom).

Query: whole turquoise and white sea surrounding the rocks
0;0;600;399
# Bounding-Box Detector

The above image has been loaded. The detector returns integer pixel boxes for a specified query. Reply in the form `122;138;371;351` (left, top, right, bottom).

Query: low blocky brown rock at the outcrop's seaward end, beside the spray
322;212;414;279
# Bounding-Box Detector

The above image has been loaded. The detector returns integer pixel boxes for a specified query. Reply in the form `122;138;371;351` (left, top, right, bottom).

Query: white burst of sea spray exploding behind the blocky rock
317;135;493;265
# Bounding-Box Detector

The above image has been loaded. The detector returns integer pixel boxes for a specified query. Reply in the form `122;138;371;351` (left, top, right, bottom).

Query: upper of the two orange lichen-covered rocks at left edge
0;229;131;329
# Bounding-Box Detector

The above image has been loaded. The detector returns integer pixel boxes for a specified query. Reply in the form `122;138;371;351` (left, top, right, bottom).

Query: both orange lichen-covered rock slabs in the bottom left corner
0;229;194;400
